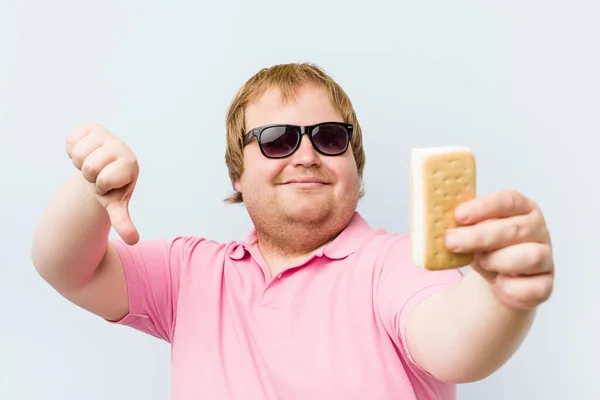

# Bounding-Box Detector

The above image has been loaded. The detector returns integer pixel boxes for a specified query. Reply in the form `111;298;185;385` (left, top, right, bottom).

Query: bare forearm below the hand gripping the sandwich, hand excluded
407;271;535;383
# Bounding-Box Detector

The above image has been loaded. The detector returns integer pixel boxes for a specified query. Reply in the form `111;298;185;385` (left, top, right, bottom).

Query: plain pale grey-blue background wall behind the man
0;0;600;400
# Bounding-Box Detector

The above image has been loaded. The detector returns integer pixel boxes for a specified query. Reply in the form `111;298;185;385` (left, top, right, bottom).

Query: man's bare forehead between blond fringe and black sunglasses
245;84;344;130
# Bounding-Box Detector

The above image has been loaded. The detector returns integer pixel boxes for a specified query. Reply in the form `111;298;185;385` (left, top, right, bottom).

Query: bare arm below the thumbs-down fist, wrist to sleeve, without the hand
32;171;128;320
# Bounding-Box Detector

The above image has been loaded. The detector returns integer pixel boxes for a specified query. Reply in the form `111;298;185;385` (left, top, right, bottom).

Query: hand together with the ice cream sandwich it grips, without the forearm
411;147;554;310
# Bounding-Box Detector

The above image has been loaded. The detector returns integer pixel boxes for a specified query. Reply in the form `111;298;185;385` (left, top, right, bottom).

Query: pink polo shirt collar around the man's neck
229;211;371;260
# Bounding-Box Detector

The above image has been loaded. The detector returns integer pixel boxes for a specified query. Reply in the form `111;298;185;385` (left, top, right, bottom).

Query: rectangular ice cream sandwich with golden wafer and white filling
410;147;476;270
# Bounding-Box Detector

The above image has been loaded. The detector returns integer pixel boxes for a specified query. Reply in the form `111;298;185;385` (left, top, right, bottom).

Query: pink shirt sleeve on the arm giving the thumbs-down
108;237;186;342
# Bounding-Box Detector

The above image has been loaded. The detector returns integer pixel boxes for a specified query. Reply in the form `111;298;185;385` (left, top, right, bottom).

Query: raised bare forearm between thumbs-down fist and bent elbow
31;171;111;288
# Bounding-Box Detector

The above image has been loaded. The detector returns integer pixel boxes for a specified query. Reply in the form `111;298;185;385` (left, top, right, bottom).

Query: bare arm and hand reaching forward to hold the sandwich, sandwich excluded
406;191;554;383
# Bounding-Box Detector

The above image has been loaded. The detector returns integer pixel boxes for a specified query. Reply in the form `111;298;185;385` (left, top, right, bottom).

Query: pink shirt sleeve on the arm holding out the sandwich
375;238;463;377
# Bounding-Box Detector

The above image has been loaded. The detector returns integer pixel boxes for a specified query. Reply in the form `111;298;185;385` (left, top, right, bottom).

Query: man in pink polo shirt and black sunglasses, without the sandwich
32;64;554;400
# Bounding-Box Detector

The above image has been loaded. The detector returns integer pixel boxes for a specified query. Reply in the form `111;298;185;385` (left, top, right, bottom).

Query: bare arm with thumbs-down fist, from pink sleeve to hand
31;125;139;320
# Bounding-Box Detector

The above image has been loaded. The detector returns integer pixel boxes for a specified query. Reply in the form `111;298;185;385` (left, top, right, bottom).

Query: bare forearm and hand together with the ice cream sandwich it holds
406;147;554;382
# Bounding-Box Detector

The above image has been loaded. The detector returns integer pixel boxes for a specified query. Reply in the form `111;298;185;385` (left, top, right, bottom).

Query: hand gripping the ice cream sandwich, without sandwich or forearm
445;190;554;309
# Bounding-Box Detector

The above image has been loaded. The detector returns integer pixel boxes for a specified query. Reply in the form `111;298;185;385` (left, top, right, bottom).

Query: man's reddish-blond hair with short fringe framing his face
225;63;365;203
